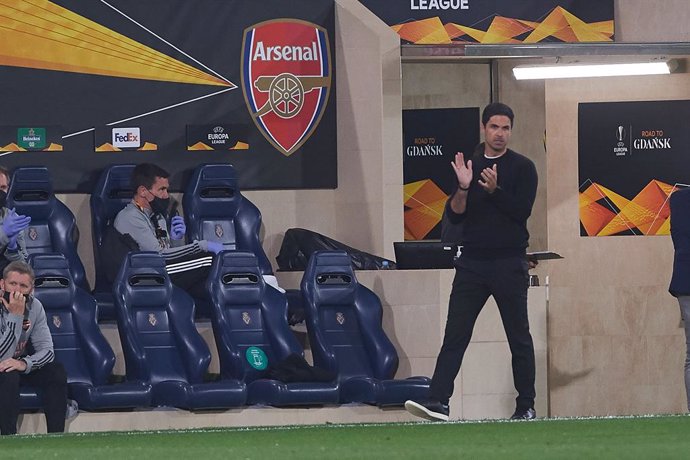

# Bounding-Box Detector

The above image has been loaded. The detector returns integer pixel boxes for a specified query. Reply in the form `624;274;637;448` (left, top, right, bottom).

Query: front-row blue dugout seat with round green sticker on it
209;251;338;406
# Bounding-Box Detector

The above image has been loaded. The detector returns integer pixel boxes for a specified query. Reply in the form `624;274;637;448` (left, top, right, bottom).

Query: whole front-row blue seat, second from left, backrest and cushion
114;252;247;410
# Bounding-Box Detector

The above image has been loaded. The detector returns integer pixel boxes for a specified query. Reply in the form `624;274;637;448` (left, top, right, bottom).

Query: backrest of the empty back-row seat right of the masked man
182;163;273;275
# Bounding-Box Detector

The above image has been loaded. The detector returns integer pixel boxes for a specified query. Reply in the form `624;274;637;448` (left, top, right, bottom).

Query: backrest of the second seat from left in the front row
114;252;211;384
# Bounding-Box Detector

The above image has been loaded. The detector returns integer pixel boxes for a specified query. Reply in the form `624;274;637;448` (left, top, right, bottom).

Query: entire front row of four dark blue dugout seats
22;251;428;410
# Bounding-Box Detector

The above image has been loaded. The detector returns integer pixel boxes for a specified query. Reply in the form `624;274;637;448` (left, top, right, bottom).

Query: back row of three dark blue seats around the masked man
8;163;273;319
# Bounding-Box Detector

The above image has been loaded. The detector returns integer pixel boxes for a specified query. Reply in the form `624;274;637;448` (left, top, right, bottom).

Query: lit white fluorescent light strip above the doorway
513;62;671;80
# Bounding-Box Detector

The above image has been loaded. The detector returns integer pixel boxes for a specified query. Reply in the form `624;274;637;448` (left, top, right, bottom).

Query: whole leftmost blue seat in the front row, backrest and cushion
31;254;151;410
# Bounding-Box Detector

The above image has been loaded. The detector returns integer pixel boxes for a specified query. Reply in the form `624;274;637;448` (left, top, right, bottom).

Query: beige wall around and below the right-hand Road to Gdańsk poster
546;74;690;416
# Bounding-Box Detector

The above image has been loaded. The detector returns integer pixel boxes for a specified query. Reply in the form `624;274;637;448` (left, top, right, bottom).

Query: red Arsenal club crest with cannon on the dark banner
242;19;331;156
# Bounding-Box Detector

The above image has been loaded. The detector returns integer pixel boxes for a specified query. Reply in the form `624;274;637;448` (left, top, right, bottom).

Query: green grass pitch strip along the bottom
0;415;690;460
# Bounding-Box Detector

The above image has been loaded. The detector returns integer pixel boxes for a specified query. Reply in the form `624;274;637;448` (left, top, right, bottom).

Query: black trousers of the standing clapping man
430;256;535;409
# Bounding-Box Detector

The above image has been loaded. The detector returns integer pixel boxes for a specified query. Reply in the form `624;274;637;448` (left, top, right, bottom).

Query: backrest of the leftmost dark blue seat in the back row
7;166;89;291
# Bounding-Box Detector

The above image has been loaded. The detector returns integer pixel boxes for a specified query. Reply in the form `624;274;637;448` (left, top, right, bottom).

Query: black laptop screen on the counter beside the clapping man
393;241;458;270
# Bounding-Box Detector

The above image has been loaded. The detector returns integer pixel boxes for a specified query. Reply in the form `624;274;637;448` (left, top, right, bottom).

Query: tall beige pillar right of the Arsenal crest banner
328;0;403;258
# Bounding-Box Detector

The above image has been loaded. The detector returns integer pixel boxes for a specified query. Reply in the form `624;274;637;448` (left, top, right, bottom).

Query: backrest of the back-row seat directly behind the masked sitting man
90;164;135;292
